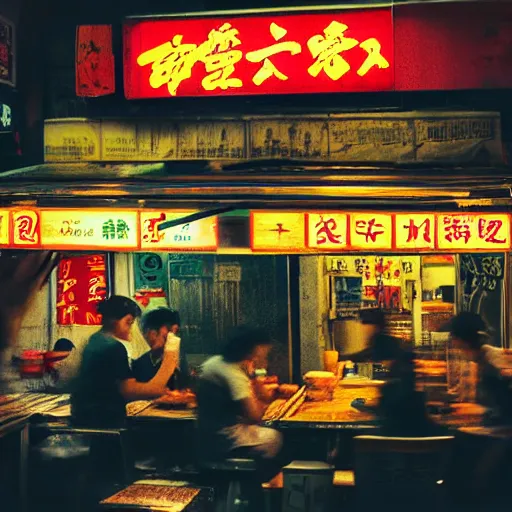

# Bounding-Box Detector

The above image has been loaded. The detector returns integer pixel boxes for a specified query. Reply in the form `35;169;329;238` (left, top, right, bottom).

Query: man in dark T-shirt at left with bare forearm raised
71;295;177;427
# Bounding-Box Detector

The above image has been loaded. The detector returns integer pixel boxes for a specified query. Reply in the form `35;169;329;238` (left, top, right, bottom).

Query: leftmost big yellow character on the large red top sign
137;34;198;96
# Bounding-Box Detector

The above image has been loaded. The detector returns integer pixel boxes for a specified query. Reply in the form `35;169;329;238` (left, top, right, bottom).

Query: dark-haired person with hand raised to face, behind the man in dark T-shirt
132;308;189;389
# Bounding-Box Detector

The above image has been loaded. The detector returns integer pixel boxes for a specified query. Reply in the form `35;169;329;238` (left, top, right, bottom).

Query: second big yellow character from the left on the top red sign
199;23;243;91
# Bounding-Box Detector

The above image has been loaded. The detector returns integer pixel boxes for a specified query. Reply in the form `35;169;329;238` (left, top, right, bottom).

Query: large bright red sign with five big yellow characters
124;9;394;99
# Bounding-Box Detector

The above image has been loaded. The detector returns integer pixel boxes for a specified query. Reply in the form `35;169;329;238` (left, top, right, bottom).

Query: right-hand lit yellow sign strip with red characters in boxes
251;211;511;253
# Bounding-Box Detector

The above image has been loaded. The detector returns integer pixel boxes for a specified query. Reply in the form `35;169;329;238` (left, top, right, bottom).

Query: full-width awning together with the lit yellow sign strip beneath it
0;161;512;254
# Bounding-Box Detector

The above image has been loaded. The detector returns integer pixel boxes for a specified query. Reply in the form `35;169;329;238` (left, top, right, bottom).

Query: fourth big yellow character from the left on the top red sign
308;21;359;80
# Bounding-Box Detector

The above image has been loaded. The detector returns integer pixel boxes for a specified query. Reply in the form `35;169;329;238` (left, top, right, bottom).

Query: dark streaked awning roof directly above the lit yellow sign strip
0;160;512;211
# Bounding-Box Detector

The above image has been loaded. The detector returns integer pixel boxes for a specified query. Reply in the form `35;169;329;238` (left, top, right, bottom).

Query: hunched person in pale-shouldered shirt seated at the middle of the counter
197;326;282;481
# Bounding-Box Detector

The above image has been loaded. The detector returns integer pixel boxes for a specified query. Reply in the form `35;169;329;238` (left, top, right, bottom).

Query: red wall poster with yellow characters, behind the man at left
57;254;107;325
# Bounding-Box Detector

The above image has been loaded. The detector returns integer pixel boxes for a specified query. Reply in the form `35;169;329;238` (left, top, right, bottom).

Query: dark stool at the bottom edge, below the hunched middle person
199;459;263;512
